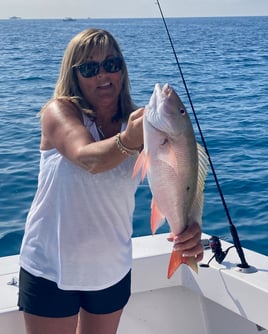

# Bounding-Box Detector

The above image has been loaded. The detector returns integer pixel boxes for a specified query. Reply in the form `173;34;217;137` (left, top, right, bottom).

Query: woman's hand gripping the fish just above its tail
168;223;204;262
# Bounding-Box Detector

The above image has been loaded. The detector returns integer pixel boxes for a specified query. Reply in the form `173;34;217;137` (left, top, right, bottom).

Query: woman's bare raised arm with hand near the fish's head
41;101;143;173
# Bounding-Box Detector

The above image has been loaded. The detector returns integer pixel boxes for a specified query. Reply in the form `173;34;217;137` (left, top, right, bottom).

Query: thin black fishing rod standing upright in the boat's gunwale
156;0;253;272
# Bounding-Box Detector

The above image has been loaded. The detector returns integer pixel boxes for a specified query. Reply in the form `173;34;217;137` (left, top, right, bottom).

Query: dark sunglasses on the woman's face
74;57;123;78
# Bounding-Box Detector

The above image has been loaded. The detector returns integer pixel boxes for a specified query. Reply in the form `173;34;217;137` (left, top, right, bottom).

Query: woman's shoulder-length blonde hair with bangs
44;28;136;120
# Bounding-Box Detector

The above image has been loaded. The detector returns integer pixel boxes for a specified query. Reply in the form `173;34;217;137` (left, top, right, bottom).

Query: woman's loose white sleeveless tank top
20;116;139;290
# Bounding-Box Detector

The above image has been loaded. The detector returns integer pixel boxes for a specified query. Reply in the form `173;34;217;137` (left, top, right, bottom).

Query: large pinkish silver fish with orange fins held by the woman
133;83;209;278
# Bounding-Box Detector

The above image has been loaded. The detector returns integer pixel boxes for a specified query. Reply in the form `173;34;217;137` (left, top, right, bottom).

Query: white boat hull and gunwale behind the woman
0;234;268;334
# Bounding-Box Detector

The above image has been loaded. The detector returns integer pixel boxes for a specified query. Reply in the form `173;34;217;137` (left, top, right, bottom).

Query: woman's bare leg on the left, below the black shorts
24;313;78;334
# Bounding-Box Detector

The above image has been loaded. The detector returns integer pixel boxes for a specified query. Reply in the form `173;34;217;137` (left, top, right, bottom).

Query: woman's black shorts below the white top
18;268;131;318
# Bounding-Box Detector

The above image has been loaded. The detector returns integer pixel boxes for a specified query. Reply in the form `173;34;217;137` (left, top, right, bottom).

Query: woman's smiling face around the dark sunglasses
77;50;122;111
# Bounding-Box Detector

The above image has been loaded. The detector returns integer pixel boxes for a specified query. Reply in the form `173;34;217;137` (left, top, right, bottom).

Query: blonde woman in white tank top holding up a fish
18;29;203;334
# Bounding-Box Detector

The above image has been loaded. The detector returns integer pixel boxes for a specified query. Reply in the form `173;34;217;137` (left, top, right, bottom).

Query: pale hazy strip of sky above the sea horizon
0;0;268;19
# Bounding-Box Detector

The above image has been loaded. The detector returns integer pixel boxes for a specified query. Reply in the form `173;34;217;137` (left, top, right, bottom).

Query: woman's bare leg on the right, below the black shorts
76;309;123;334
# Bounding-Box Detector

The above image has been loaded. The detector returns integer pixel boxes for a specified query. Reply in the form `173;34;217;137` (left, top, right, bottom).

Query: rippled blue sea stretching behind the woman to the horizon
0;17;268;256
